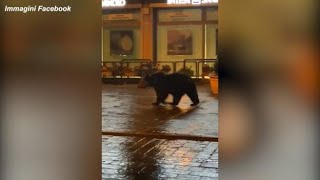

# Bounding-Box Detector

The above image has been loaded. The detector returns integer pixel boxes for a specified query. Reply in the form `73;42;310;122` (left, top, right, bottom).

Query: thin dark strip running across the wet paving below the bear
102;131;219;142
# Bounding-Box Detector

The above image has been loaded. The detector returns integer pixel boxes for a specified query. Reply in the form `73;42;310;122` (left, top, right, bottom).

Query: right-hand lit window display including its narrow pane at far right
156;8;218;75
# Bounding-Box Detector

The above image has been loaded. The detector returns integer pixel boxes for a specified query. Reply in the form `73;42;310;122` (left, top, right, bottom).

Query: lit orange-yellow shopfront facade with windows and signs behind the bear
102;0;218;76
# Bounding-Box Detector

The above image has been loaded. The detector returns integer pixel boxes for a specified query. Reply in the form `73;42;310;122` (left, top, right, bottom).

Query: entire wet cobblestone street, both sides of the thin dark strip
102;84;218;180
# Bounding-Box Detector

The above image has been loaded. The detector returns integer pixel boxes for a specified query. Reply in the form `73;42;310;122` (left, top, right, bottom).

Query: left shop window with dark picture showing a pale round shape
102;10;140;61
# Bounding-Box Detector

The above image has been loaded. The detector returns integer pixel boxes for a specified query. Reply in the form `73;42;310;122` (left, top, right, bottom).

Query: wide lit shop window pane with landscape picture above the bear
157;8;203;75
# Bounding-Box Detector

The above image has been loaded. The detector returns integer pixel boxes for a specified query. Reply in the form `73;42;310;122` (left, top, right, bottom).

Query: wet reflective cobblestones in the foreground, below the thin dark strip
102;136;218;180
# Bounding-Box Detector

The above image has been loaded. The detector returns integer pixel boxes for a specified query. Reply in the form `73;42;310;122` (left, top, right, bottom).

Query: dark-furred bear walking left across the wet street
138;72;199;106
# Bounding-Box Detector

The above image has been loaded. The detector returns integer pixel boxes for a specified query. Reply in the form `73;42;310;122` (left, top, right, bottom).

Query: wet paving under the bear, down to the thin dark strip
102;85;218;137
